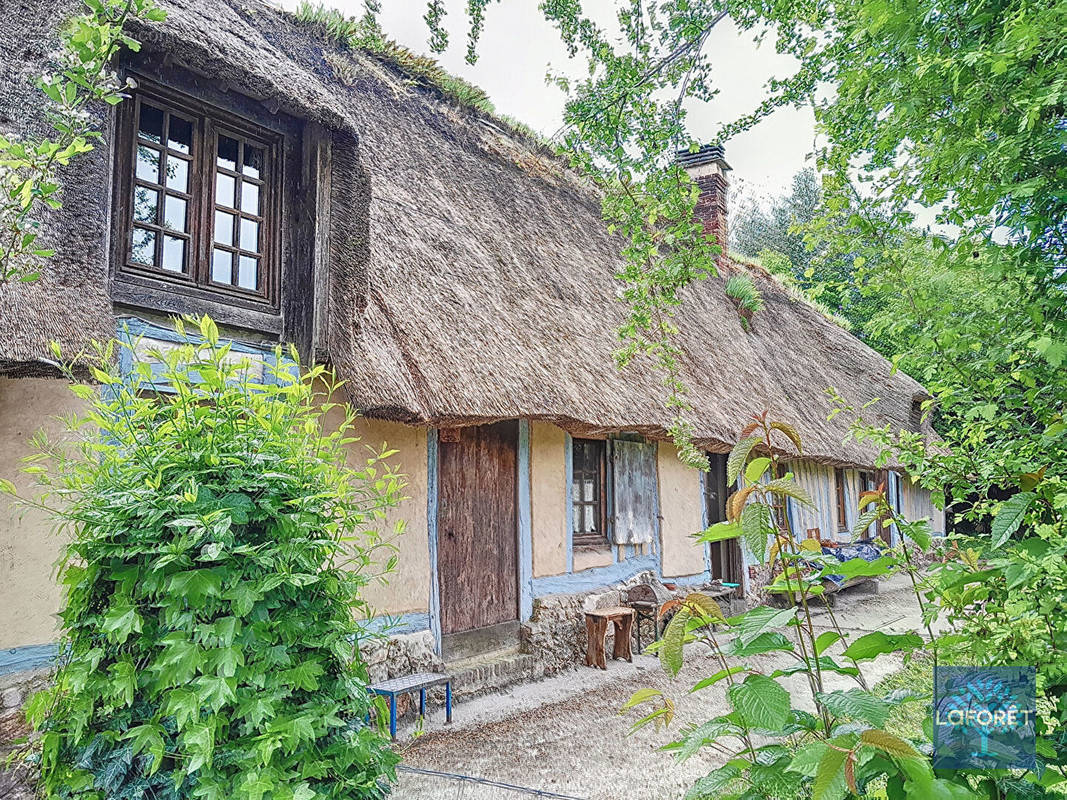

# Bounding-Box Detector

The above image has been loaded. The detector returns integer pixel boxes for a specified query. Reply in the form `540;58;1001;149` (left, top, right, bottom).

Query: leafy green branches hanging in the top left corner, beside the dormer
0;0;166;287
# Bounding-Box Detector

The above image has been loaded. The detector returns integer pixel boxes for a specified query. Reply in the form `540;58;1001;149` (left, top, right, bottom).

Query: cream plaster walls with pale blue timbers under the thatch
0;379;944;667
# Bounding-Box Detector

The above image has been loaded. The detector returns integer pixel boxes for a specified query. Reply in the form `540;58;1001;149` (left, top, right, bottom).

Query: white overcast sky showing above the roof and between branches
283;0;813;195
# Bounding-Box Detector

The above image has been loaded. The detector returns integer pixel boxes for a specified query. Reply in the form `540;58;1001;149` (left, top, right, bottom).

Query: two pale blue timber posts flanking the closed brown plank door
426;419;534;656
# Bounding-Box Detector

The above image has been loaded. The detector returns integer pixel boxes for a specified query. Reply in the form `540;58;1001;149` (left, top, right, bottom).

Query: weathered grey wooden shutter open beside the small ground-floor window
611;439;658;544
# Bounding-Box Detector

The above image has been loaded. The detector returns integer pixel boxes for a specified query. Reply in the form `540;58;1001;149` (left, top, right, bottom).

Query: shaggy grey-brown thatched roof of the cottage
0;0;924;465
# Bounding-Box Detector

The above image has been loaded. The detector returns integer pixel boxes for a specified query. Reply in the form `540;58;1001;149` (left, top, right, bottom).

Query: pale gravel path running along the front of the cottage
395;576;920;800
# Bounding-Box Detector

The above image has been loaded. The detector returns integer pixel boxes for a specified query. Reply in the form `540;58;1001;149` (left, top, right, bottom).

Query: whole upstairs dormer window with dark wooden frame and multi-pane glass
120;87;282;305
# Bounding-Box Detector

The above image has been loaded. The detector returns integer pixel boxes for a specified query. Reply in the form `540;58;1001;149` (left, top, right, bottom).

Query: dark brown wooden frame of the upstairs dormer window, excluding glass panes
115;76;286;314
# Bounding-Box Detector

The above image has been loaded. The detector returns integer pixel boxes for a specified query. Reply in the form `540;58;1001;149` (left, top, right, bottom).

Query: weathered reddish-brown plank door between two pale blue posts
437;421;519;635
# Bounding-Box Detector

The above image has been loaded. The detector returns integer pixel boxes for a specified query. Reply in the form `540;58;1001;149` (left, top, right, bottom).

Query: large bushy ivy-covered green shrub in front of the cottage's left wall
14;318;403;800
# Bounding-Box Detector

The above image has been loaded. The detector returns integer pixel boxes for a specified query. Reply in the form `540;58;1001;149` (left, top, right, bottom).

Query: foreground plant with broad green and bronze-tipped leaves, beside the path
627;414;978;800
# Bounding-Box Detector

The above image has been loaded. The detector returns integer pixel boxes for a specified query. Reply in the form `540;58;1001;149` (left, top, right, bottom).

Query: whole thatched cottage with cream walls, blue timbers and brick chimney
0;0;934;691
